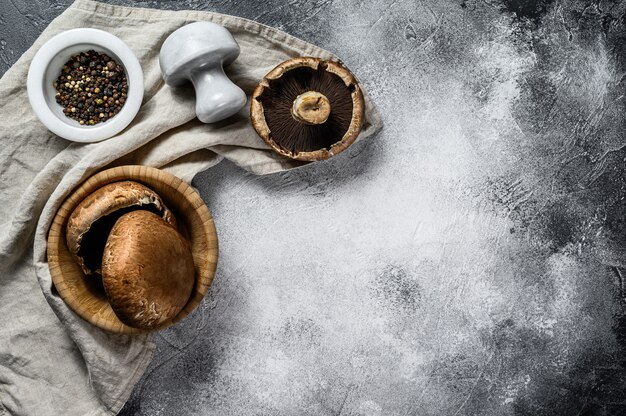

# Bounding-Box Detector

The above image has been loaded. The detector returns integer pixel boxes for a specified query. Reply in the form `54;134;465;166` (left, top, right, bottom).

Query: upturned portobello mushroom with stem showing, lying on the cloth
250;57;365;161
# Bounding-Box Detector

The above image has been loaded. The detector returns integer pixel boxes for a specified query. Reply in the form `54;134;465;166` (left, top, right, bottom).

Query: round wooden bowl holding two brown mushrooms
48;166;218;334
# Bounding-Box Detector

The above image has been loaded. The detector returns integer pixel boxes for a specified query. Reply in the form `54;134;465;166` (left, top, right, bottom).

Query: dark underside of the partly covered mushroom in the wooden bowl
78;203;163;273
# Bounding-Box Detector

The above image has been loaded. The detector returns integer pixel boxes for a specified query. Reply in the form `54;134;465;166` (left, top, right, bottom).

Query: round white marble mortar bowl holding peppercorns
27;28;144;143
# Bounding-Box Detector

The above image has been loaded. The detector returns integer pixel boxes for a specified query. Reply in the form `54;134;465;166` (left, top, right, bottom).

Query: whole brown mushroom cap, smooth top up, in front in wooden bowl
102;210;195;329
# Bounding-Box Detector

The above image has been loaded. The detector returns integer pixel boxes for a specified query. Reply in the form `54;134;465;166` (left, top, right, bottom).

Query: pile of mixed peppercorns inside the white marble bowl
53;50;128;125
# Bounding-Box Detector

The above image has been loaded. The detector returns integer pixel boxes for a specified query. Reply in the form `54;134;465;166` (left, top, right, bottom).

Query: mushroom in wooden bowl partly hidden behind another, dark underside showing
65;181;176;274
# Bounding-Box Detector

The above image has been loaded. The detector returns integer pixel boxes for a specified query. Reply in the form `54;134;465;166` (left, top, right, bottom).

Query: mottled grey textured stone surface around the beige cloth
0;0;626;416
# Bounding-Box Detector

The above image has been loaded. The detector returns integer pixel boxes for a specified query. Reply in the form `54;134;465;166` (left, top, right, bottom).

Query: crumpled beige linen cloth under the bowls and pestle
0;0;381;416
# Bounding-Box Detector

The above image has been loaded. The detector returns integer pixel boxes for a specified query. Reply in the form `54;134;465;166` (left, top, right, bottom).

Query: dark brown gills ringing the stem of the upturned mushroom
257;65;354;153
